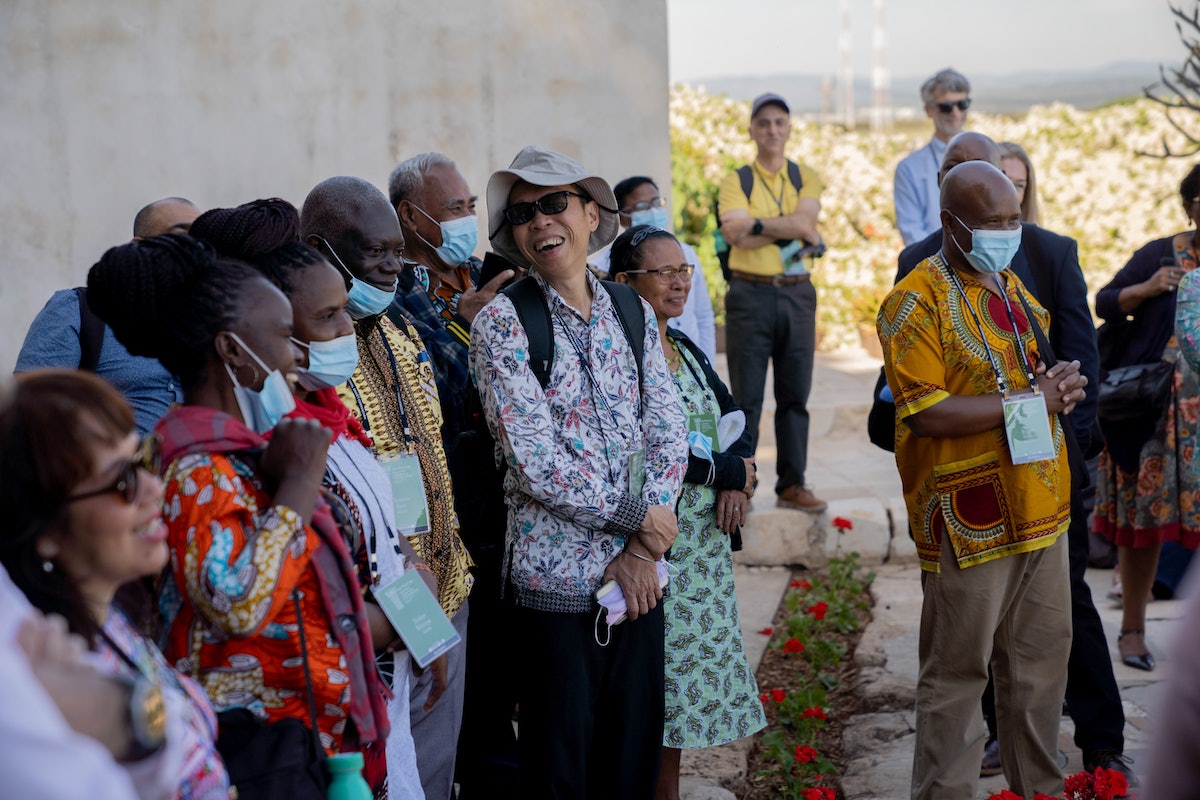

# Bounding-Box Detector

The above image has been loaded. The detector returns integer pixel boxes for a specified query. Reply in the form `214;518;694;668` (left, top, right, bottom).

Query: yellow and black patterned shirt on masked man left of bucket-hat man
337;317;474;616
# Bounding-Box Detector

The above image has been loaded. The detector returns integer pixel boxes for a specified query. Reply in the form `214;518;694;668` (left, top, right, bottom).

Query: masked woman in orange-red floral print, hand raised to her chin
88;235;388;783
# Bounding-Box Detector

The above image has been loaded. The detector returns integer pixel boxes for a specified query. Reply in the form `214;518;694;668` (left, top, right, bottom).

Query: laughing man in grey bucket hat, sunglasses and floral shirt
470;146;688;799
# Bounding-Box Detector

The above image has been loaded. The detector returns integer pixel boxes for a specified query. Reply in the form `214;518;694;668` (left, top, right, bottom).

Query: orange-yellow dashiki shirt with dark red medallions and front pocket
877;253;1070;572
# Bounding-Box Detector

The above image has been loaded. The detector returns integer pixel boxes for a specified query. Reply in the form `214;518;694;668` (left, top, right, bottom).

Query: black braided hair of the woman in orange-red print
88;234;263;391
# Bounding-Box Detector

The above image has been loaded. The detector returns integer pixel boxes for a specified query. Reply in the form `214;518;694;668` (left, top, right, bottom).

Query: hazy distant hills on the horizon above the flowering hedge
686;61;1159;114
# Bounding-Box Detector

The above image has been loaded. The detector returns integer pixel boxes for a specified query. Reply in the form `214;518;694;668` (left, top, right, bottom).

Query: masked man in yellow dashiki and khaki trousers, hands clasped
878;161;1087;800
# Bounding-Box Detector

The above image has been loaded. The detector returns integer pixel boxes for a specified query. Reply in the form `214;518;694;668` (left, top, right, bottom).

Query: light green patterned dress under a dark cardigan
662;345;767;750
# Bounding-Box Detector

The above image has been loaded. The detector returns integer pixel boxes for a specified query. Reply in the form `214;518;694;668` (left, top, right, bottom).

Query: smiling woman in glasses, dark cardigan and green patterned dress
610;225;767;800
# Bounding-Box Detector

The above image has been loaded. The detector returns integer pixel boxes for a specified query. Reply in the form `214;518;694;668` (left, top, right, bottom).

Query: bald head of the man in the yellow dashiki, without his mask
942;161;1021;271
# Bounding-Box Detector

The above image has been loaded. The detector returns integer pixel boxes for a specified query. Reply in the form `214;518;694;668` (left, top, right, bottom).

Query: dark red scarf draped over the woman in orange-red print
155;405;390;745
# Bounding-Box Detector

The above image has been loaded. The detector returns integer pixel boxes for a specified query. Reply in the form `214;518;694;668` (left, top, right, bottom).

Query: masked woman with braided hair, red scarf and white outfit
192;199;437;800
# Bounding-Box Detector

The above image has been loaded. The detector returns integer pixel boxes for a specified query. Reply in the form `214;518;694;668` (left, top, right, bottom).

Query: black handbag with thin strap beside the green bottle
216;590;329;800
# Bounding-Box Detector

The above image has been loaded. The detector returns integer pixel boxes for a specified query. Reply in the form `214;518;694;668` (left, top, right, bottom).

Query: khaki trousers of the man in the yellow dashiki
912;534;1070;800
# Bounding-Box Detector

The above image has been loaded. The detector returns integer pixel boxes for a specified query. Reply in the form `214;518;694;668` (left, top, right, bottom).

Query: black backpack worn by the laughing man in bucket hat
446;277;646;561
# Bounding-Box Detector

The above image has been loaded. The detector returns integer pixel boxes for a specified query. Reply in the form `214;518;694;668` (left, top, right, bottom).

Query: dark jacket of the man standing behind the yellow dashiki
896;222;1100;453
